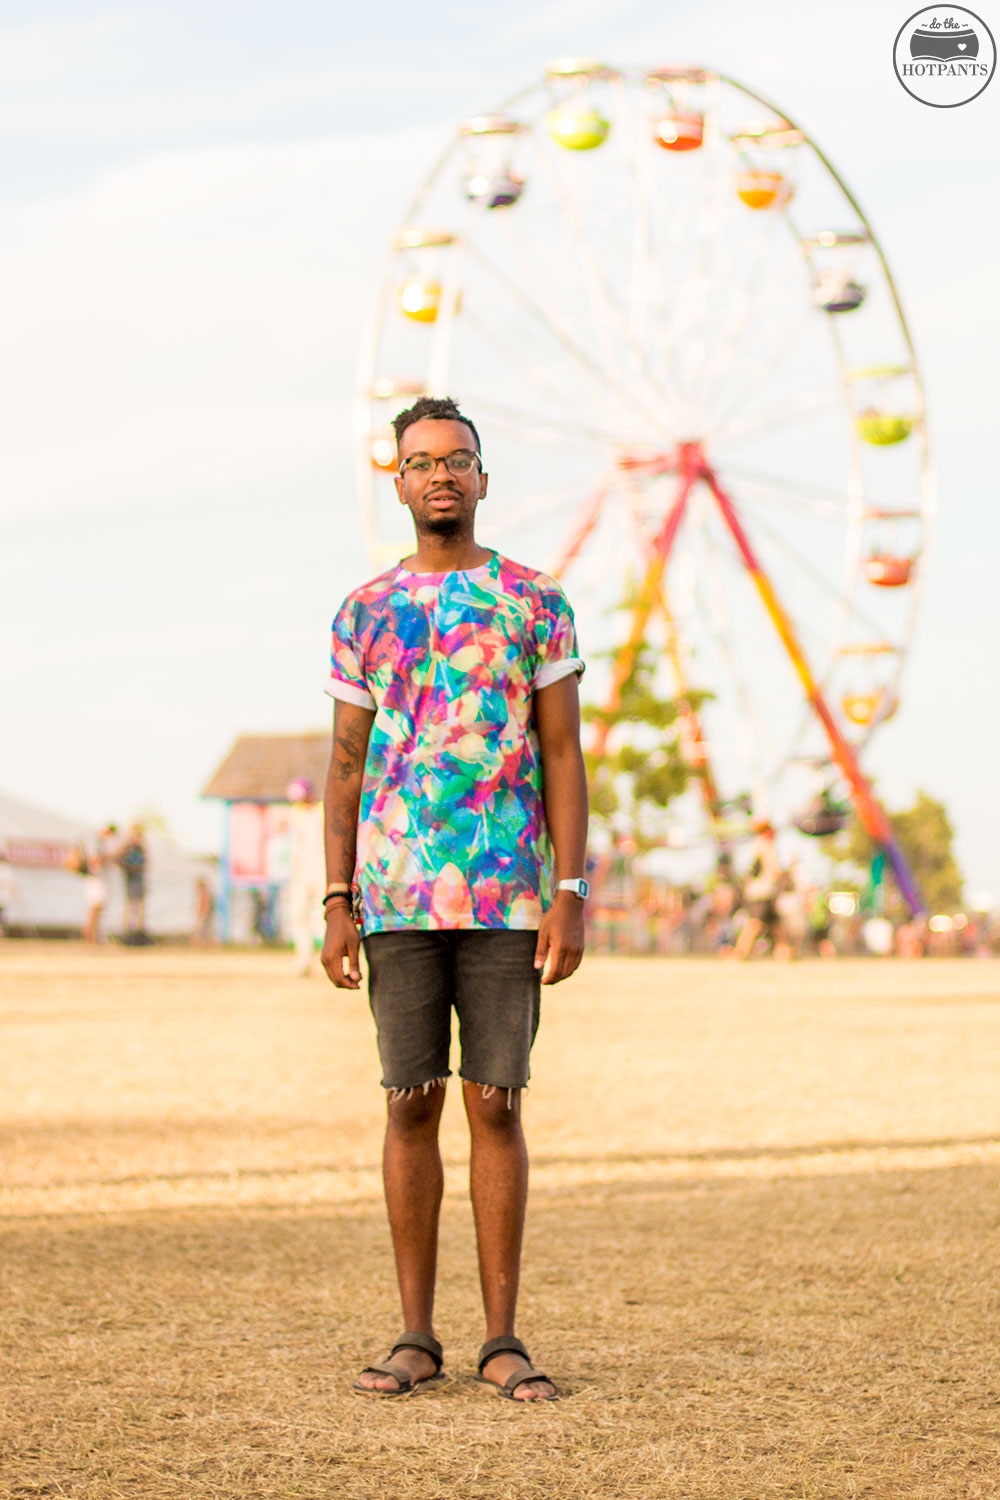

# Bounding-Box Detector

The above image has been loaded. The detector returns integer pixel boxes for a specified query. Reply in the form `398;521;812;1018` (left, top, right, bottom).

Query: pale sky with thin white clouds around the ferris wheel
0;0;1000;899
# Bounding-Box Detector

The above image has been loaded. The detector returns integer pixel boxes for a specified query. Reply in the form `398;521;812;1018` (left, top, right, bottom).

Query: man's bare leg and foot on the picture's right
462;1083;555;1401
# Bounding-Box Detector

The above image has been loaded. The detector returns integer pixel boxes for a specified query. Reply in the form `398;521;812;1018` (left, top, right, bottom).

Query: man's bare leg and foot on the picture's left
358;1085;444;1391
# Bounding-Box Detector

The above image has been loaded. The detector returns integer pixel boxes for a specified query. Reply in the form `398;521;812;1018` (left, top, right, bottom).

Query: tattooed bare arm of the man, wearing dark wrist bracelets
322;699;375;990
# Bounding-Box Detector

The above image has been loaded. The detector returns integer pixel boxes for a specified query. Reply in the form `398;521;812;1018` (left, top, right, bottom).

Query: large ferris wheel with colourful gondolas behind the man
357;59;933;911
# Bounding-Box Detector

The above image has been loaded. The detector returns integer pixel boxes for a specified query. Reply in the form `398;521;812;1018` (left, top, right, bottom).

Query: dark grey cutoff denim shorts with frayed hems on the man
364;927;541;1094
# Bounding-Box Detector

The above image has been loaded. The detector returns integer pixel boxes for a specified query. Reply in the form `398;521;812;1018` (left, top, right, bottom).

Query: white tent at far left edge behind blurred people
0;794;216;938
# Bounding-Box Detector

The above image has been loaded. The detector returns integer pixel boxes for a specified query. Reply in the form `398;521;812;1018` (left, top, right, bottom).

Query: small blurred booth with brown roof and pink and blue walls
201;729;330;942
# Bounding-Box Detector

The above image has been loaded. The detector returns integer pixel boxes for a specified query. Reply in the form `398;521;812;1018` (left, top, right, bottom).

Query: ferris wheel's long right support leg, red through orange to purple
700;459;927;915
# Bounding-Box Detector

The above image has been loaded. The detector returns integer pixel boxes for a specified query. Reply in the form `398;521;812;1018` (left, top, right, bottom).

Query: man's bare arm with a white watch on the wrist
534;672;588;984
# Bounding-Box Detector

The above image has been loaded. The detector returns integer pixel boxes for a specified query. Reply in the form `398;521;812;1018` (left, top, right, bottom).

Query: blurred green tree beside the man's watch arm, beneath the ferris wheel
583;642;708;851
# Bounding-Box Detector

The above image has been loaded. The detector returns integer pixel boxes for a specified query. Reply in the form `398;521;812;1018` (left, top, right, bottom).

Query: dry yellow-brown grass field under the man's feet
0;944;1000;1500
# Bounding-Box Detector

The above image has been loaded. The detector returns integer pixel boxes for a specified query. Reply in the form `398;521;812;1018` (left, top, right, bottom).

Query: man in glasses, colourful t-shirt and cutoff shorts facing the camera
322;398;586;1401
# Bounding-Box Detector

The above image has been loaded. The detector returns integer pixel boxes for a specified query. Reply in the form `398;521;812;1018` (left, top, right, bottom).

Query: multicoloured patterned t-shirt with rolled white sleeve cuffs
327;552;583;933
